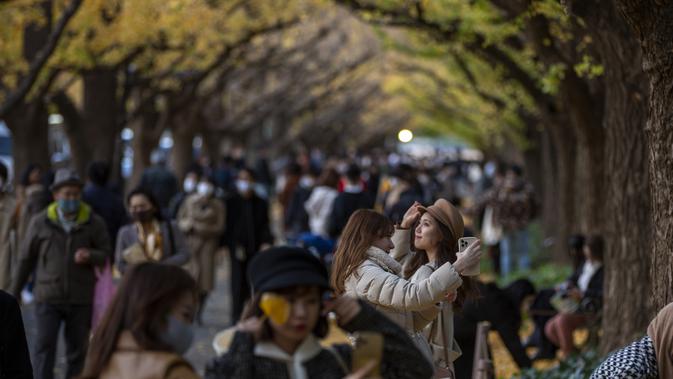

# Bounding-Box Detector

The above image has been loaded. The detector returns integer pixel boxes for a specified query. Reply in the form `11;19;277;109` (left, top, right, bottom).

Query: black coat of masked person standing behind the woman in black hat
224;194;273;258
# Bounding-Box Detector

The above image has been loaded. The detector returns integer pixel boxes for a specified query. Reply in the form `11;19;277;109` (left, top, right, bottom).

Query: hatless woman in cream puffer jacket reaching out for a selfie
332;210;481;372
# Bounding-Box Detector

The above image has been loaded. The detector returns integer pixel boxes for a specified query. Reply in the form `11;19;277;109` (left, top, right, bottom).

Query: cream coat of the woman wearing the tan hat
391;229;462;367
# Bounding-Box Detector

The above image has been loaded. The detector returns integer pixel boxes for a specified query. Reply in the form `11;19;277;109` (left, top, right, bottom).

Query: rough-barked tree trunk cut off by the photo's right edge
618;0;673;316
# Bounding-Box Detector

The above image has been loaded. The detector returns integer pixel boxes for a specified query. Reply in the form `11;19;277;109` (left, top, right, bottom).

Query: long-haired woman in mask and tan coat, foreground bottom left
81;262;198;379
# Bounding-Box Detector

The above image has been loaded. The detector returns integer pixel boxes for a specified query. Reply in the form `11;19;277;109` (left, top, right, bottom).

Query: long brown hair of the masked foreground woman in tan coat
81;262;198;379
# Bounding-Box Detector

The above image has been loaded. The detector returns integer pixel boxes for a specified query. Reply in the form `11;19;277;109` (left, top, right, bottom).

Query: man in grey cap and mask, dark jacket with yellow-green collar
11;169;112;379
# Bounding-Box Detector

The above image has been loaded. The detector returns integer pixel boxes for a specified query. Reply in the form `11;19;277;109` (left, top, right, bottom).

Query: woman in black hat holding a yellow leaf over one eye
206;247;433;379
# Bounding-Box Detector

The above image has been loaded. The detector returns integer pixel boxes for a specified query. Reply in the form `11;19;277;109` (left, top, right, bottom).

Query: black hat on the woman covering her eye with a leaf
247;246;329;293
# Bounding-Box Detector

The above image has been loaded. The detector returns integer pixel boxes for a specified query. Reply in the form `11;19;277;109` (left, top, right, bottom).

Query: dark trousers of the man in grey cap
34;303;92;379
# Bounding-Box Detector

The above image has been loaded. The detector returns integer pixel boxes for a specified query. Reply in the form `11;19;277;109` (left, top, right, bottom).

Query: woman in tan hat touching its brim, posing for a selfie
391;199;481;378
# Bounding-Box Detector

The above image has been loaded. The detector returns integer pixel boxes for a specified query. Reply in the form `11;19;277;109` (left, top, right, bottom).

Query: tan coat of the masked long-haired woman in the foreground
100;331;199;379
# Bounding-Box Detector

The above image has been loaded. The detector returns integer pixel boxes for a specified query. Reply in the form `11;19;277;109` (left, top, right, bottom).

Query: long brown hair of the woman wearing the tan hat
404;215;479;311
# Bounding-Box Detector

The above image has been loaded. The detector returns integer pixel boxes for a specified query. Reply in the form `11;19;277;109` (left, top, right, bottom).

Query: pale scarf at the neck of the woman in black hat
255;334;322;379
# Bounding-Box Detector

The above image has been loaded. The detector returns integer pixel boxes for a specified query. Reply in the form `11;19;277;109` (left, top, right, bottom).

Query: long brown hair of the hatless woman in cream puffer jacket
332;209;395;295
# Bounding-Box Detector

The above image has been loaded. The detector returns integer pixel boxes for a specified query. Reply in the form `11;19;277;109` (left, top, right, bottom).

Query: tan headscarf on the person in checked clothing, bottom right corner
647;303;673;378
